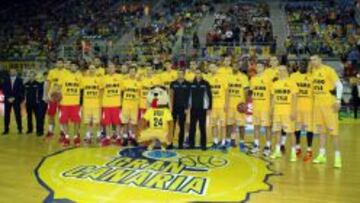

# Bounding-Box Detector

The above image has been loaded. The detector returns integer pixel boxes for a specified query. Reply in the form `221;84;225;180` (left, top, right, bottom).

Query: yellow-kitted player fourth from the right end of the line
250;64;272;156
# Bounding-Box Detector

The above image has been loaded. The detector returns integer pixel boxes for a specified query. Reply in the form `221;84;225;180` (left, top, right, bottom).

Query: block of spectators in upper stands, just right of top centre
206;2;274;45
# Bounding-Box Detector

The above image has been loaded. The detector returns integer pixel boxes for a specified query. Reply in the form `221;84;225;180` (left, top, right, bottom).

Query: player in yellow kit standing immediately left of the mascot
121;67;141;145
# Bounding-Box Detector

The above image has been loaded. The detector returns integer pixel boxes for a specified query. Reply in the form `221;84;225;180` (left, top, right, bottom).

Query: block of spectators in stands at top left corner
0;0;144;59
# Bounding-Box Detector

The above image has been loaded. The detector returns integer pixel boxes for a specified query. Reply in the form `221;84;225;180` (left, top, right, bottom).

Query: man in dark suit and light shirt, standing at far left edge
3;68;24;135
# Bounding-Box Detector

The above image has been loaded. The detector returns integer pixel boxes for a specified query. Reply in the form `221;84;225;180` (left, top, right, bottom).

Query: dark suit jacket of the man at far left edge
3;76;24;102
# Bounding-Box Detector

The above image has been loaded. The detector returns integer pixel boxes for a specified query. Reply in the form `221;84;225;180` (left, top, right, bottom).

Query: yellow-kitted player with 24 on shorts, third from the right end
270;66;298;162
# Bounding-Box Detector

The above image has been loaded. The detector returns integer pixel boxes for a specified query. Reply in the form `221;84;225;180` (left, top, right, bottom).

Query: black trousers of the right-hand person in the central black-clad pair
189;109;206;149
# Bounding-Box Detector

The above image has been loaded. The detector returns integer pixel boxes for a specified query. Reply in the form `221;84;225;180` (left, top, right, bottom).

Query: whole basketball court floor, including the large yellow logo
0;117;360;203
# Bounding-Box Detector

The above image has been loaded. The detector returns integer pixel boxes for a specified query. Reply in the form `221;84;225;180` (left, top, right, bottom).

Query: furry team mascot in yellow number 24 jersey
139;86;173;150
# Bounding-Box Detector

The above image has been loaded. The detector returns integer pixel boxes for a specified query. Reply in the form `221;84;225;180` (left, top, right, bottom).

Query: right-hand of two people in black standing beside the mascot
189;69;212;150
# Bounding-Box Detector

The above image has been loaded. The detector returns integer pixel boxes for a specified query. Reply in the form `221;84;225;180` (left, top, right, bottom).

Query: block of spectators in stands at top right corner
285;1;360;61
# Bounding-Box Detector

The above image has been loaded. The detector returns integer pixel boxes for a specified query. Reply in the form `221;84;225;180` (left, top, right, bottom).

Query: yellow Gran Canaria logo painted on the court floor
35;147;275;202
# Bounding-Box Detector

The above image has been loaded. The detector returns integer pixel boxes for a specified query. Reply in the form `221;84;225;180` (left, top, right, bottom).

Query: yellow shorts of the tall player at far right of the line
313;105;339;136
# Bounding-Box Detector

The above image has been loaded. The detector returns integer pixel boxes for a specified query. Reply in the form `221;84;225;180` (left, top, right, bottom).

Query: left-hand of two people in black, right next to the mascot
170;70;190;149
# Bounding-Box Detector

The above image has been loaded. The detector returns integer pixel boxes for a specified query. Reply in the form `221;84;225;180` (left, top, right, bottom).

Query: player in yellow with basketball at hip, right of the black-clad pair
226;64;249;152
